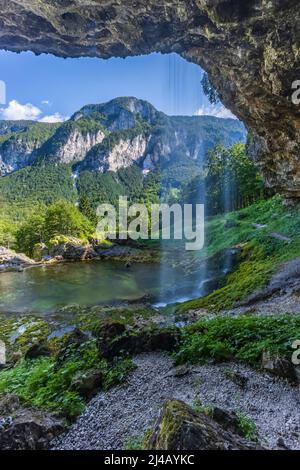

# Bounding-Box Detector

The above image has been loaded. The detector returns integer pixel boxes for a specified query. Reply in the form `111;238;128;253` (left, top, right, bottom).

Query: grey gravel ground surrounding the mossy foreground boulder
53;353;300;450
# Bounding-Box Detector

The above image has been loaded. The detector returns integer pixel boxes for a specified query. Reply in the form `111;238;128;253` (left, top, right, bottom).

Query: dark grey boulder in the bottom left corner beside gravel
0;395;64;450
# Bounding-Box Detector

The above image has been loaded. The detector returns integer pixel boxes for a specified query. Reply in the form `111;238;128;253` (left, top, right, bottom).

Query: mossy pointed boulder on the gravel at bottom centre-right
146;400;263;451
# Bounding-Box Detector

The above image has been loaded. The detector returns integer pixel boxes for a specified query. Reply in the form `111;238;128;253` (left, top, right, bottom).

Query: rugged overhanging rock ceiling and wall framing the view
0;0;300;200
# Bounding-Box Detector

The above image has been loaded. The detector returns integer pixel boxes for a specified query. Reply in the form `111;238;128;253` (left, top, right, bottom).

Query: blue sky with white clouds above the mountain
0;51;236;122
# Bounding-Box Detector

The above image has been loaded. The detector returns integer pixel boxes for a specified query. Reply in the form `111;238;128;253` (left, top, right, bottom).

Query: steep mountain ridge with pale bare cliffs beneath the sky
0;97;246;179
